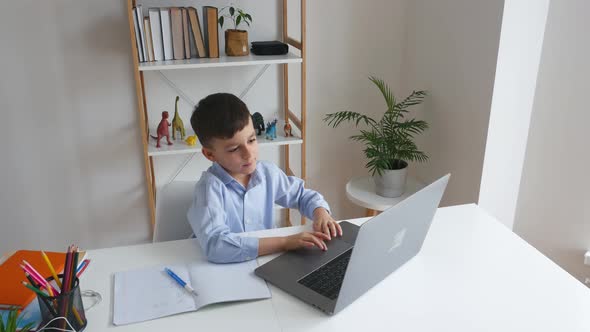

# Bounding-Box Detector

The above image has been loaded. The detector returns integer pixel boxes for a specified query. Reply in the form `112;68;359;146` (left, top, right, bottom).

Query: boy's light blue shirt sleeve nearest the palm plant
269;165;330;220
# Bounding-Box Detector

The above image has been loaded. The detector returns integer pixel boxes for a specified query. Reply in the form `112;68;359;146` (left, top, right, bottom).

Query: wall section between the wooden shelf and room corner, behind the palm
307;0;406;219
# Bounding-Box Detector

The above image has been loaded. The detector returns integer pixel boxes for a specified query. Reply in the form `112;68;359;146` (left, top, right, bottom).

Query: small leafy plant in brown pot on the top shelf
218;6;252;56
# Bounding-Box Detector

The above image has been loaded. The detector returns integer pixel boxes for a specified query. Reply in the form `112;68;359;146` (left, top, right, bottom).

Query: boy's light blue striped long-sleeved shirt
187;161;330;263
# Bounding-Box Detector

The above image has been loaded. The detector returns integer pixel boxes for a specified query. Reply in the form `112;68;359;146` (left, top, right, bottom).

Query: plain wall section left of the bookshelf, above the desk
0;0;150;253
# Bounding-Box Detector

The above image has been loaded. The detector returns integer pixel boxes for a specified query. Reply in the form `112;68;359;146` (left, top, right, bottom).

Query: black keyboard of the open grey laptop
298;248;352;300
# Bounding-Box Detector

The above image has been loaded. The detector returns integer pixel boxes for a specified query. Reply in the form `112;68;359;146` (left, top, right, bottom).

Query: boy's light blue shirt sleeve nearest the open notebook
187;181;258;263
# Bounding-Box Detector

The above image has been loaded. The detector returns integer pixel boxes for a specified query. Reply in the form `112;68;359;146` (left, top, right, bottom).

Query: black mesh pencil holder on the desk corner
37;274;87;331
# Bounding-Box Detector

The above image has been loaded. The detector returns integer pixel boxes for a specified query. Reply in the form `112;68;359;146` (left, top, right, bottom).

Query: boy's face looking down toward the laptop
202;119;258;180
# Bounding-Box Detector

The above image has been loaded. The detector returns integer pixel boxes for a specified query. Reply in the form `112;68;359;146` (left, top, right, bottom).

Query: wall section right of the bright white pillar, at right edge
514;0;590;280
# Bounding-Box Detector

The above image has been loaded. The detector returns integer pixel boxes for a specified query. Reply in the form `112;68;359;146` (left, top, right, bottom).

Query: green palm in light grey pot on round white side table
324;76;428;197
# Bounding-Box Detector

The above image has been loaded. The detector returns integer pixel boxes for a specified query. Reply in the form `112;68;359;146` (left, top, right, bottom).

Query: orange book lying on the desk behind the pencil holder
0;250;85;308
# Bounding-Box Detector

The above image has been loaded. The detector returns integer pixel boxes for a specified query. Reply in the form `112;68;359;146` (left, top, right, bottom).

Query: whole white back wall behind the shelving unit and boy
0;0;404;252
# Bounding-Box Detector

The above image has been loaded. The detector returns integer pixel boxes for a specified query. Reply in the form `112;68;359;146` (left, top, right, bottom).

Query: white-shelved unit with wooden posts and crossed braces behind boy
127;0;307;229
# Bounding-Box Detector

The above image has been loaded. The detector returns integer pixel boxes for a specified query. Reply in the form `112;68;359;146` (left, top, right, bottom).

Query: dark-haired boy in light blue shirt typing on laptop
187;93;342;263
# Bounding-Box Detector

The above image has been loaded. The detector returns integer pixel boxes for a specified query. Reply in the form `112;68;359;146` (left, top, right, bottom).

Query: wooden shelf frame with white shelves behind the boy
127;0;307;233
